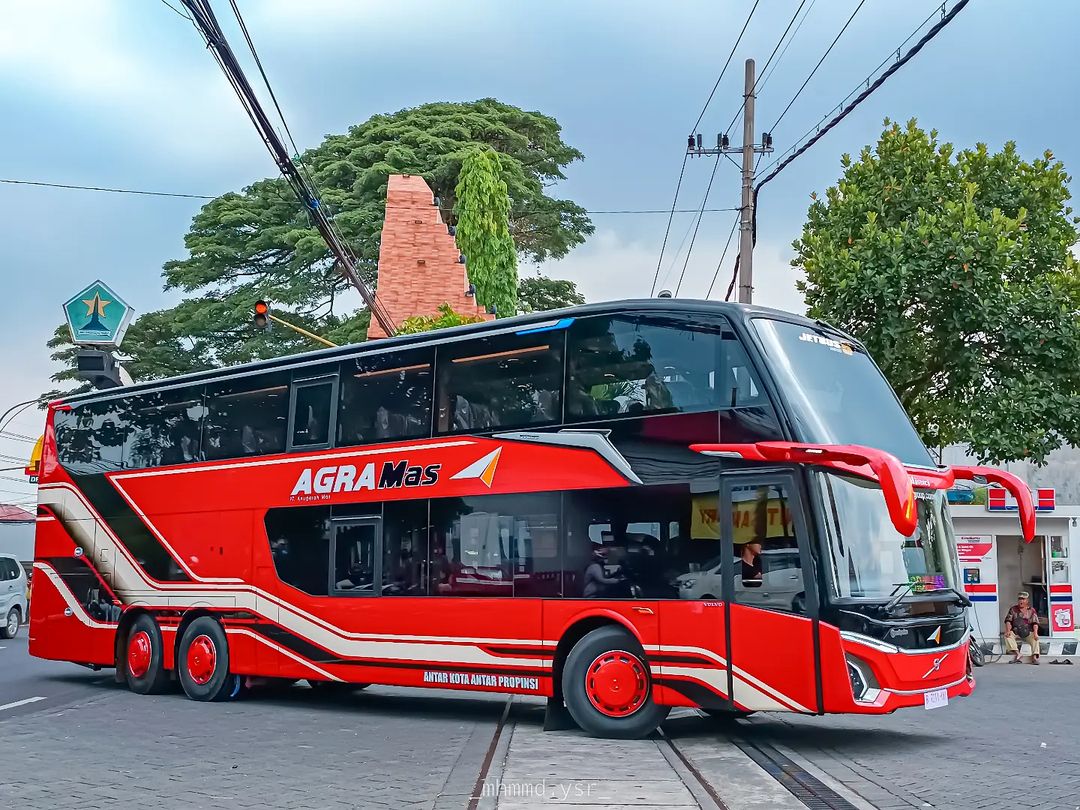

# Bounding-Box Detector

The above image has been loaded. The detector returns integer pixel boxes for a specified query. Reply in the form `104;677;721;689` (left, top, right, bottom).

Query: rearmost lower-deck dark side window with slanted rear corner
266;507;330;596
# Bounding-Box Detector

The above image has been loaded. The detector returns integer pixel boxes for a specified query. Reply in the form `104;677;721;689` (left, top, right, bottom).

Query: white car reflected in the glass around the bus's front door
675;549;804;610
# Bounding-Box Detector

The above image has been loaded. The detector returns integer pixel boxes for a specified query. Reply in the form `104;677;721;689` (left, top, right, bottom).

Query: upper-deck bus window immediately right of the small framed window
338;349;434;447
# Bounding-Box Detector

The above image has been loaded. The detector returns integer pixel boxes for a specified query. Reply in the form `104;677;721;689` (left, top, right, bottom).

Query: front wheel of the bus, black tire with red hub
563;626;671;740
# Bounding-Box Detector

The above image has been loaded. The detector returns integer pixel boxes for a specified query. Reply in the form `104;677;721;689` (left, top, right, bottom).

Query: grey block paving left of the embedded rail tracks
0;686;502;810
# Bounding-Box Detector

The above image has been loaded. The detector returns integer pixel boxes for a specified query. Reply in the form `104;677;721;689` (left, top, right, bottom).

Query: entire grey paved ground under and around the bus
0;634;1080;810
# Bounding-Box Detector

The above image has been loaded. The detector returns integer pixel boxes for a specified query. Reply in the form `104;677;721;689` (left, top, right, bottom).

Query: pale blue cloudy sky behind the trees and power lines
0;0;1080;502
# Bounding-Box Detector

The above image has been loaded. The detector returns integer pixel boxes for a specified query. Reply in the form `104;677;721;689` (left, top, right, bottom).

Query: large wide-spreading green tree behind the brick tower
50;98;593;390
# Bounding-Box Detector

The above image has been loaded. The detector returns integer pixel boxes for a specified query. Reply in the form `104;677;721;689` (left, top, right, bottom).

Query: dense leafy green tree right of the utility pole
792;120;1080;463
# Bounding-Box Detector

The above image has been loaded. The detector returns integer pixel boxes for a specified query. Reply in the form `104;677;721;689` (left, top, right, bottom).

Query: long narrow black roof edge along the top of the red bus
50;298;838;407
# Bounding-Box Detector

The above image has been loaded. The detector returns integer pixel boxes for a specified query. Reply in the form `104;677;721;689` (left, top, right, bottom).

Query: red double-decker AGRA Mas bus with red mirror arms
30;300;1034;737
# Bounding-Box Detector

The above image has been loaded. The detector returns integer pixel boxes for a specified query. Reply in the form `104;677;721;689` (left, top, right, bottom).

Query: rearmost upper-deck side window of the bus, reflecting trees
55;400;132;473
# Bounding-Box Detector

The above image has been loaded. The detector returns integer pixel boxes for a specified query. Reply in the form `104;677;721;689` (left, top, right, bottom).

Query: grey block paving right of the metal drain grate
725;660;1080;810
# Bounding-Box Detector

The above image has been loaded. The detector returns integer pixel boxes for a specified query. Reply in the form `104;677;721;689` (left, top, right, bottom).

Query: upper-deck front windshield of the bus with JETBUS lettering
753;318;934;467
